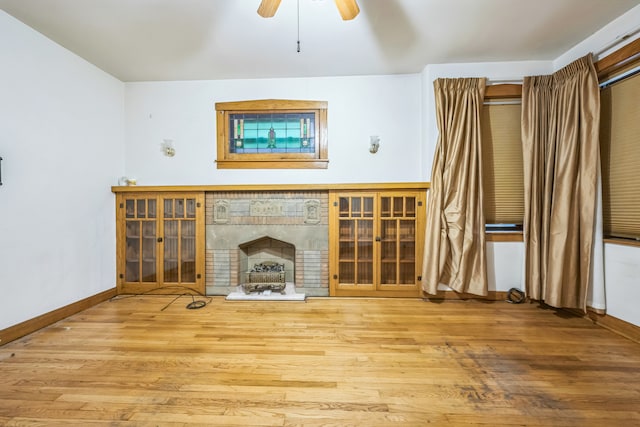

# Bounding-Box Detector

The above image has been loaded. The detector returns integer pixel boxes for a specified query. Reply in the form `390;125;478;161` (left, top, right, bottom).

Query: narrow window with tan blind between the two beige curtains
482;99;524;232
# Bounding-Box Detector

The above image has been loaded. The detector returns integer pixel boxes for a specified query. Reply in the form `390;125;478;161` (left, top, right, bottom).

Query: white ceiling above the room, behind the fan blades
0;0;640;81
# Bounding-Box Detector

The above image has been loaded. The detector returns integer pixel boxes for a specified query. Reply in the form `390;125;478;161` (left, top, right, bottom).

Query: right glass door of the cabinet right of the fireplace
380;196;416;286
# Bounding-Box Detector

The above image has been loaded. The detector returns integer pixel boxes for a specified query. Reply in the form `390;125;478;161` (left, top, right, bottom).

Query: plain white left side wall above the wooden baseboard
0;11;124;332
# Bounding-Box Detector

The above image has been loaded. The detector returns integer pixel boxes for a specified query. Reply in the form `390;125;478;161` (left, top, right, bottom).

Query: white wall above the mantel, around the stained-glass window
126;74;428;185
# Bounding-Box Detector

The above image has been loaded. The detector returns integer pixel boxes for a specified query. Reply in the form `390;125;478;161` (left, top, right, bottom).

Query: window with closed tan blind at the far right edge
600;64;640;241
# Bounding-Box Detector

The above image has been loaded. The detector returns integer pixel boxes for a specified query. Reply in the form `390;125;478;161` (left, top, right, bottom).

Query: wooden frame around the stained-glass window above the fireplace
215;99;329;169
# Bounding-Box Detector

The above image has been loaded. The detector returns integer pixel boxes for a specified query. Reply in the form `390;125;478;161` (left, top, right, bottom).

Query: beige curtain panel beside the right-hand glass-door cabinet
422;78;487;295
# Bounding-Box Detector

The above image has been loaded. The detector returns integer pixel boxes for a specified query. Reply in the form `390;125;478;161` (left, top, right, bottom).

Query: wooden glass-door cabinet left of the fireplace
116;192;205;294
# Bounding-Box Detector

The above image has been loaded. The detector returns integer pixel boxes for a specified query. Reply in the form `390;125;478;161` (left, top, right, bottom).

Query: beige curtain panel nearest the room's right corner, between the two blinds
522;55;600;310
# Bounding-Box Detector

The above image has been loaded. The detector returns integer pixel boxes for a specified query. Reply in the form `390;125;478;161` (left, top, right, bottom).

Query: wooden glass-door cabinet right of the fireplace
329;191;425;296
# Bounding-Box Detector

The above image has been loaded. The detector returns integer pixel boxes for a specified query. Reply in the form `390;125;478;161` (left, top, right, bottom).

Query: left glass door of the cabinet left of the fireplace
124;198;158;283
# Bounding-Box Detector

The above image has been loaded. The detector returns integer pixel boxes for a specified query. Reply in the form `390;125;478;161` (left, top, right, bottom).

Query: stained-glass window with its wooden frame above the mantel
216;100;329;169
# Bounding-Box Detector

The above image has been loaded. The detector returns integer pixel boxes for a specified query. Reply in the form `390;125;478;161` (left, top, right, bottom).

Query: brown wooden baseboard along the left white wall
0;288;117;346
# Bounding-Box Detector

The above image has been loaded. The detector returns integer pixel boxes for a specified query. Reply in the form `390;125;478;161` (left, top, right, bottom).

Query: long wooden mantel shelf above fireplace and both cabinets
111;182;430;193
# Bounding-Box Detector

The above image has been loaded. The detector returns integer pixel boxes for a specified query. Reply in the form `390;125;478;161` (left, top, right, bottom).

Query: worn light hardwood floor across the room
0;296;640;427
